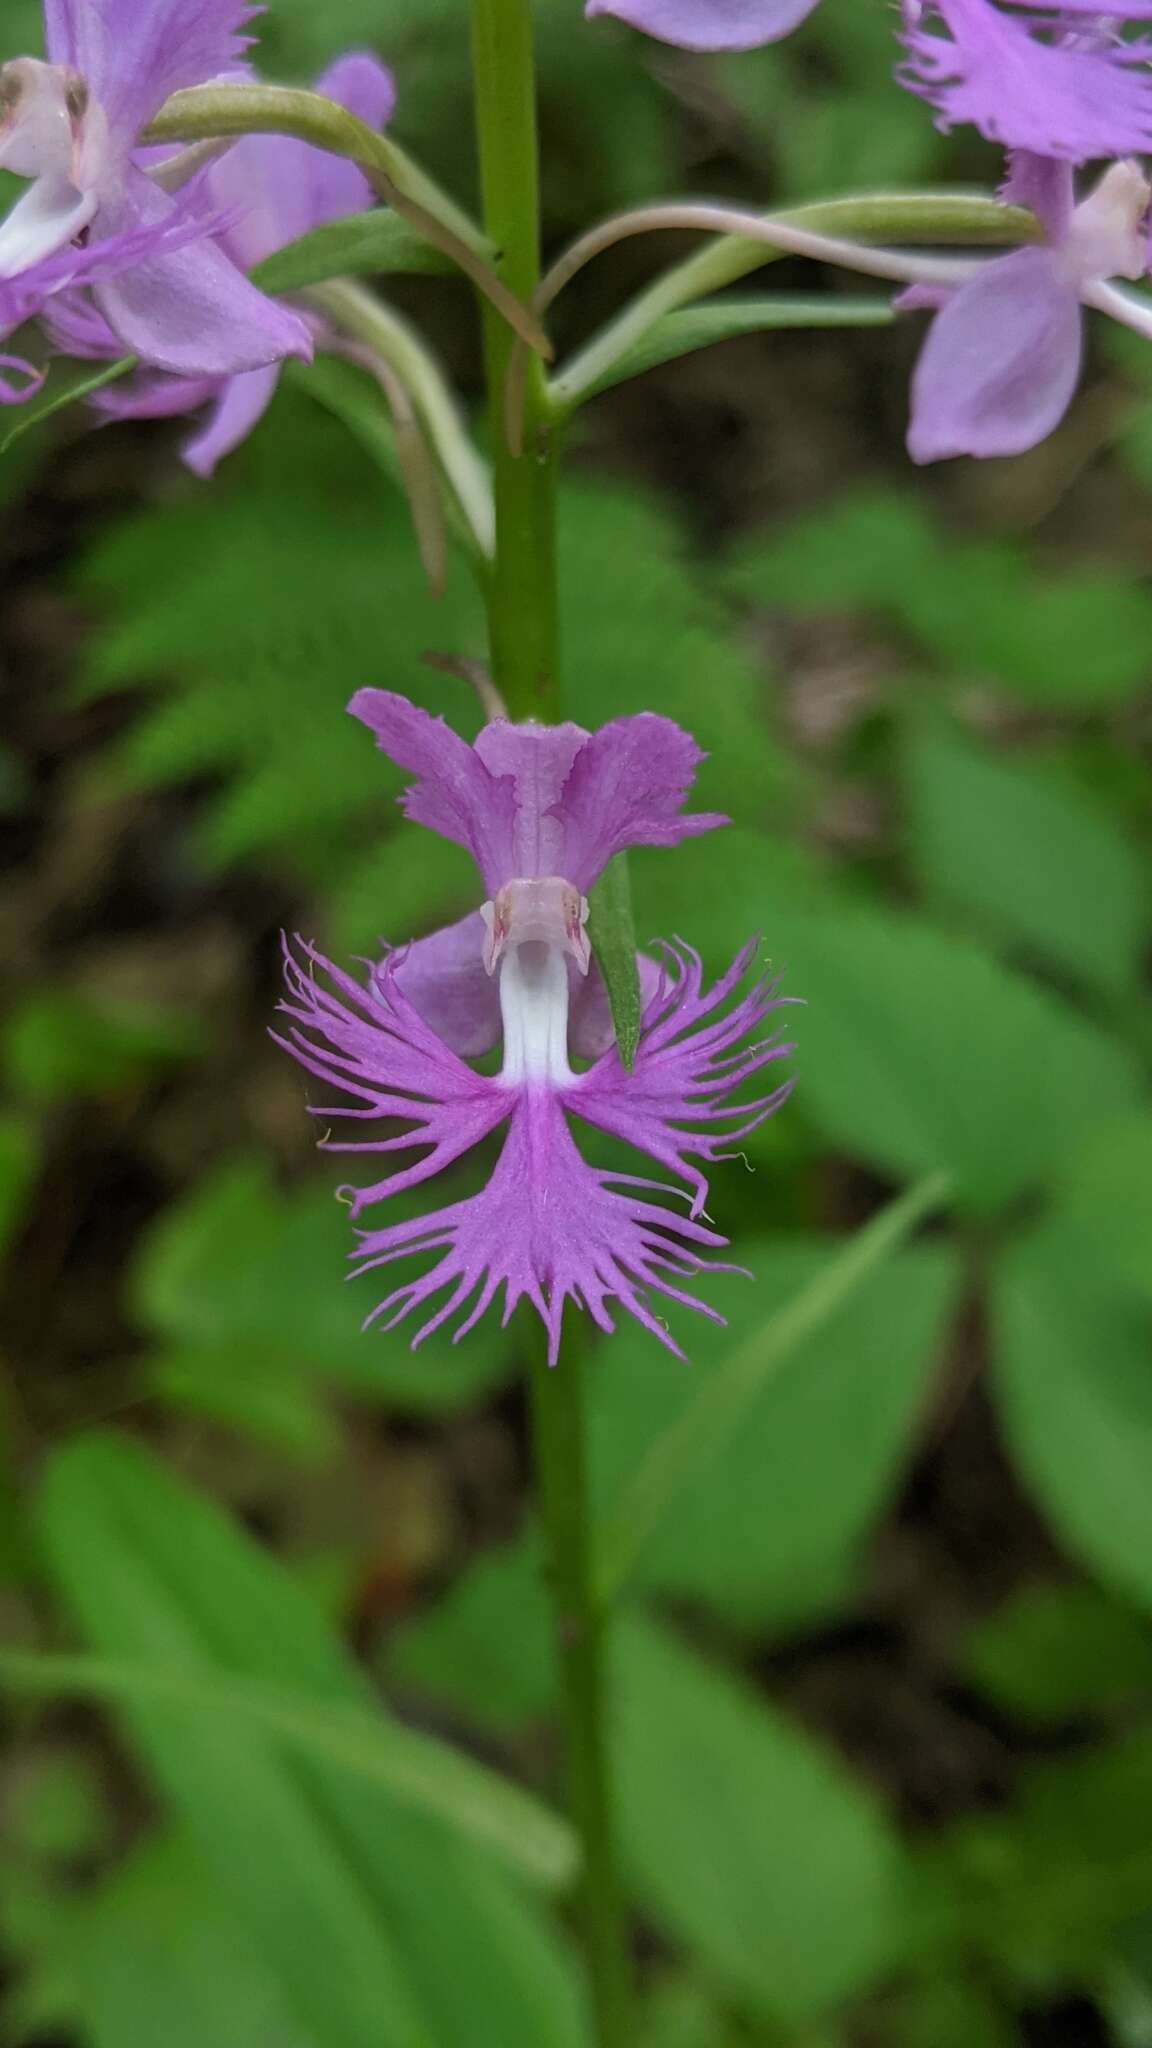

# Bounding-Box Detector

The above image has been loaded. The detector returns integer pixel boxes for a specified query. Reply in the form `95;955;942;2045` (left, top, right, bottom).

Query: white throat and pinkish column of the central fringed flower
480;874;590;1087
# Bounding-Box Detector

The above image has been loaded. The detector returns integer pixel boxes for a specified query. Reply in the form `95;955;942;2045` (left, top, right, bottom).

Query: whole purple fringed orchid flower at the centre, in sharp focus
279;690;791;1364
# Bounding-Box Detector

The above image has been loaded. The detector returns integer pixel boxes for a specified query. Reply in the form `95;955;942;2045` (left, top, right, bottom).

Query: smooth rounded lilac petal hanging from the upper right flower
908;250;1082;463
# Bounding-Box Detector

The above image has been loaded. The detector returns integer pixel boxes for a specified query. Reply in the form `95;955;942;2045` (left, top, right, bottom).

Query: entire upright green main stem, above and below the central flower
463;0;631;2048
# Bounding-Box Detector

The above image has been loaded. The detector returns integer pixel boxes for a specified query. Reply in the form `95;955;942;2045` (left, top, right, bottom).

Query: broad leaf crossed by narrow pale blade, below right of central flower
592;1180;955;1620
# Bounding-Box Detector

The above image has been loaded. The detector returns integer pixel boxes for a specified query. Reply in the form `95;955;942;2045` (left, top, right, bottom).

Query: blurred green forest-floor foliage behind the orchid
0;0;1152;2048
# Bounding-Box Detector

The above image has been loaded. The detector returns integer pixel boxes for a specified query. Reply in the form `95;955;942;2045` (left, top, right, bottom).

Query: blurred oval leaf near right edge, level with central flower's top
904;721;1148;993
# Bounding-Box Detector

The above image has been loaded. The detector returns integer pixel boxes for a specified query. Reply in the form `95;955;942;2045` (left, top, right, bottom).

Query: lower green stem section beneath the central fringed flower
529;1341;633;2048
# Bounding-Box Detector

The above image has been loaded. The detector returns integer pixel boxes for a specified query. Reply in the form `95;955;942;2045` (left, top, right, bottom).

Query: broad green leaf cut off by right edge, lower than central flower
992;1223;1152;1608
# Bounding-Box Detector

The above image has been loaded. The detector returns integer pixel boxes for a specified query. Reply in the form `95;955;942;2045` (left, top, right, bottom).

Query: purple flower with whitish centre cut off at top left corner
0;0;312;377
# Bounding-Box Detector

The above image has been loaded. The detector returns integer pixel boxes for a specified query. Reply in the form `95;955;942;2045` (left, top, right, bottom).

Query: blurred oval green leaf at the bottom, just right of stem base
613;1620;902;2019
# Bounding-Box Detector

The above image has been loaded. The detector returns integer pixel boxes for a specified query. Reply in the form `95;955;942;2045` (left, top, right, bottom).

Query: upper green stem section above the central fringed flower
471;0;558;719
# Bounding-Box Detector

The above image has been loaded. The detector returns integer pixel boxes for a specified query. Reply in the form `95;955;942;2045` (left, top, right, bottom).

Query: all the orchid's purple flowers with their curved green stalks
0;0;1152;1360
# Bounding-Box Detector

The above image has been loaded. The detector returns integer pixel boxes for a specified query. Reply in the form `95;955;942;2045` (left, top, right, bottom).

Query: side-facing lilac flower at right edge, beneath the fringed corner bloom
900;152;1152;463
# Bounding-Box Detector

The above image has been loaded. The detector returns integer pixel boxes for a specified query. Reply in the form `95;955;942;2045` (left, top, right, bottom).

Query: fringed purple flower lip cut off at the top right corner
900;0;1152;164
